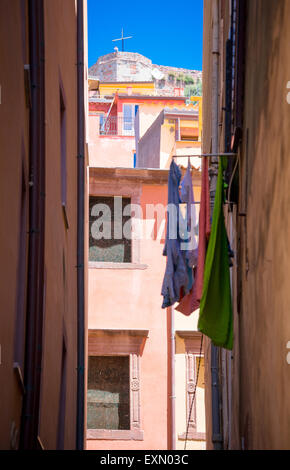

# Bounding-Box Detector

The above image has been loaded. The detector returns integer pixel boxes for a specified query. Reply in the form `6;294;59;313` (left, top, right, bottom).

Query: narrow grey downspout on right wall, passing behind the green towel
210;0;222;450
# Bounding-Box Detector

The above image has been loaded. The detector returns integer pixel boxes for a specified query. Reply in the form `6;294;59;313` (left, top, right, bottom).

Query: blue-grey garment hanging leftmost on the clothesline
161;161;189;308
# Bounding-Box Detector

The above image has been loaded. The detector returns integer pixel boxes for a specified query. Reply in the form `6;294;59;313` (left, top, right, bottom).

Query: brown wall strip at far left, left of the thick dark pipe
0;0;29;449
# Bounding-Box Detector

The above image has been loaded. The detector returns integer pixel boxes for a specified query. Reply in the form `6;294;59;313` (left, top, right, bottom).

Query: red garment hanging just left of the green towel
176;158;210;315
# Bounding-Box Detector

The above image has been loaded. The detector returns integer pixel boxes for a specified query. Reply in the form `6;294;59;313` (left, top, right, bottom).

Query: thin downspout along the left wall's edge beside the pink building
76;0;85;450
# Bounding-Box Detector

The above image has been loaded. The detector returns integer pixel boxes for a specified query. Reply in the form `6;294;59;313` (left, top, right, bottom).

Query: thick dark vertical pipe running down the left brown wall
19;0;45;449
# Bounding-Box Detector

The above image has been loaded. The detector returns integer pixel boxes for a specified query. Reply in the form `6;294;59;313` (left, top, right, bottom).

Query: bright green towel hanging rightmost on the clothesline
198;157;233;349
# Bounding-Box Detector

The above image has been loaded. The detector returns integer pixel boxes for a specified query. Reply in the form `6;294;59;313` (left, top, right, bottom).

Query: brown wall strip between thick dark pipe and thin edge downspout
39;0;77;449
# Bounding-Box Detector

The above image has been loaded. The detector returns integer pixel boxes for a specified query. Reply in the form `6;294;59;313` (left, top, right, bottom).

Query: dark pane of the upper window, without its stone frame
89;196;132;263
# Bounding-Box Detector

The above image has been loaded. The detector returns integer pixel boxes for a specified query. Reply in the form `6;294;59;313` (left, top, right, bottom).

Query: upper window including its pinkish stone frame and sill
88;175;147;269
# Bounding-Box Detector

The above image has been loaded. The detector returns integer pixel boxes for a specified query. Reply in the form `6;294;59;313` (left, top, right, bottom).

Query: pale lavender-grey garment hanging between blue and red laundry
180;159;198;268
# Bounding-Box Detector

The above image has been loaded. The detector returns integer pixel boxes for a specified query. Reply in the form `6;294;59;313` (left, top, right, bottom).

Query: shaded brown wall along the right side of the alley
203;0;290;449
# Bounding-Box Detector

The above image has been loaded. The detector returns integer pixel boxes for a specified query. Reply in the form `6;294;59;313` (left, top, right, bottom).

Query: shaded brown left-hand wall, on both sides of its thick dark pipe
0;0;87;449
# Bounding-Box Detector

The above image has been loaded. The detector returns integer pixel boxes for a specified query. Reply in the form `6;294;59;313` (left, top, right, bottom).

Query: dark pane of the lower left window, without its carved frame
87;356;130;430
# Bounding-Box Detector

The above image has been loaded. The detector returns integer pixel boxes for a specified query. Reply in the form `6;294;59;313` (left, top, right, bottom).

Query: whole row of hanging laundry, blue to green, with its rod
161;153;236;350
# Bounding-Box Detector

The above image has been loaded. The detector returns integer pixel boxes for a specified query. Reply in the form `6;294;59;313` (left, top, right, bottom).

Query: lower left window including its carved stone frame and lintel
87;329;148;441
